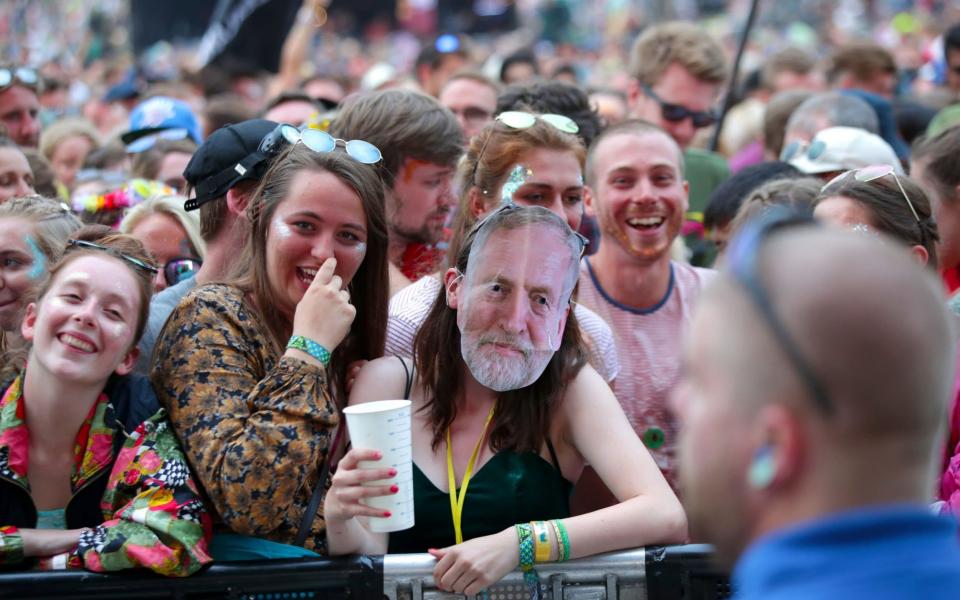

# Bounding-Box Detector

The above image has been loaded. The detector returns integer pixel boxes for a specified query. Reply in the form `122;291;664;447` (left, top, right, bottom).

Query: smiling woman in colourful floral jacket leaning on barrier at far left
0;226;211;576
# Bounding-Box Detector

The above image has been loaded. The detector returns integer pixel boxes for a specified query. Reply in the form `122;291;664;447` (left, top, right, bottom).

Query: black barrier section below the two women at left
0;556;383;600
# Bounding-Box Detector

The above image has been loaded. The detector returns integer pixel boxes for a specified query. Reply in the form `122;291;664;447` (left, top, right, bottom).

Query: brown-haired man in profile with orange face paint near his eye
330;90;466;296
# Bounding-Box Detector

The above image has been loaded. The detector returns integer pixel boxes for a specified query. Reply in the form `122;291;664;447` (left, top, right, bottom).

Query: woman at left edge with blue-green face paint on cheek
0;196;80;378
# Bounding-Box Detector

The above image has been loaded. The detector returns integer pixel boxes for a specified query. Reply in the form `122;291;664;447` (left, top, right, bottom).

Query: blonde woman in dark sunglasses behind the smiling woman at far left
120;195;207;292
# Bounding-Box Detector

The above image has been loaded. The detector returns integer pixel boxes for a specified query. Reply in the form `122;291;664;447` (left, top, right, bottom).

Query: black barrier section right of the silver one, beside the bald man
646;544;732;600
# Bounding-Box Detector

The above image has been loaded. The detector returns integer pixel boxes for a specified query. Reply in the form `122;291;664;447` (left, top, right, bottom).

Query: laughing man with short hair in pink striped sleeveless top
579;121;713;494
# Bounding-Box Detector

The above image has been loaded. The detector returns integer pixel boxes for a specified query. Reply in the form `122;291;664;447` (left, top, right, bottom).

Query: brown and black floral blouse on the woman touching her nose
151;284;339;553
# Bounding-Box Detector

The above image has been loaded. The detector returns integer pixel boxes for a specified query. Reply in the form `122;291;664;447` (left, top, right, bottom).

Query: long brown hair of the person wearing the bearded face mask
414;206;587;452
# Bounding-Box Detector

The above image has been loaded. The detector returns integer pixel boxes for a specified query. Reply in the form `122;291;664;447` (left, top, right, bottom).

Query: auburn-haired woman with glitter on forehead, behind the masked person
386;111;619;383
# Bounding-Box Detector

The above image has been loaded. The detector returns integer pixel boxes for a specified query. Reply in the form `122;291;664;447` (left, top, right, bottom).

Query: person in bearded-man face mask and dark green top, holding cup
324;204;686;595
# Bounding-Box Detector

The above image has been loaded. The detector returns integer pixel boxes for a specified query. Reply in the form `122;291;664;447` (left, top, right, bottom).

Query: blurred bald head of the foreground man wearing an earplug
674;226;955;564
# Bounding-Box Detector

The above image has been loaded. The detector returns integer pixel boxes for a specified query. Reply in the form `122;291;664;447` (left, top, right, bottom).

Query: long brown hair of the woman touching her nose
227;144;388;402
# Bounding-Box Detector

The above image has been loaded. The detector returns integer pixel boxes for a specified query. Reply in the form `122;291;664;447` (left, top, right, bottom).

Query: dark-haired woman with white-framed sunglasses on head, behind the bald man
813;165;940;270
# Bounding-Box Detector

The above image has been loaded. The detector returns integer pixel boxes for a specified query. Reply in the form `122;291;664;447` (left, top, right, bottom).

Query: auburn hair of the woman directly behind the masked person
447;119;586;265
